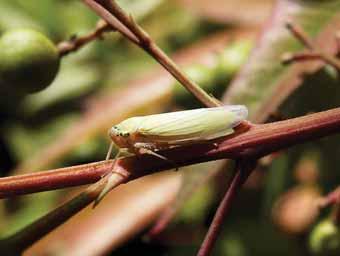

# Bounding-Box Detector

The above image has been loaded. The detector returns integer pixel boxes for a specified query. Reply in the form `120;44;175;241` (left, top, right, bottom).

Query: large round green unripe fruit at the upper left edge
0;29;60;95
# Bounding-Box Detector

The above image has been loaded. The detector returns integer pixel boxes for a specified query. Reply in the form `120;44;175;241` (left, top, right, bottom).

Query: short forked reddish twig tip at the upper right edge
284;23;340;72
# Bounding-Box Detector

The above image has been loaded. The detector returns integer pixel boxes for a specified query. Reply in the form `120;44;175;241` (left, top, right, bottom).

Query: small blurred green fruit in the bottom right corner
309;219;340;256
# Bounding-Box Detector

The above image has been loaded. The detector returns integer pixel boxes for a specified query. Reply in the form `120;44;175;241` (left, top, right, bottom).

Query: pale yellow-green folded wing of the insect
138;105;247;142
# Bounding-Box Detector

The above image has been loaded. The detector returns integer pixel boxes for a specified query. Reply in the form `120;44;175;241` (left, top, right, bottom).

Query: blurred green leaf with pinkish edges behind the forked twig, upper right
224;0;340;122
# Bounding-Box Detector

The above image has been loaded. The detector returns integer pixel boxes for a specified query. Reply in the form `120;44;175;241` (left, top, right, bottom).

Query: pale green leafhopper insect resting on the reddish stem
94;105;248;206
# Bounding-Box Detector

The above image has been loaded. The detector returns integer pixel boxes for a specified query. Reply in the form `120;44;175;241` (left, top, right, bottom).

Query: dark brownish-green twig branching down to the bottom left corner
0;167;128;255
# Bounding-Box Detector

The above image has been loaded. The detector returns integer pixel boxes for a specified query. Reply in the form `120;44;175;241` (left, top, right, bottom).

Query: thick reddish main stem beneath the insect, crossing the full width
0;108;340;198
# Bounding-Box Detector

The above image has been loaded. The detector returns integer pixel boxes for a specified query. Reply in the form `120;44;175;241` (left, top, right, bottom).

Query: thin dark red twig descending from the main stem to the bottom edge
197;159;256;256
